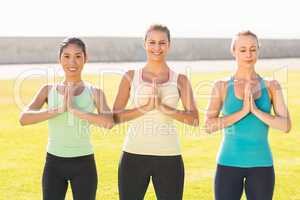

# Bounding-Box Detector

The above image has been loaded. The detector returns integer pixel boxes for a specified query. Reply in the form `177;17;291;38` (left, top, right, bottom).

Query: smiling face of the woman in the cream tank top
144;30;170;61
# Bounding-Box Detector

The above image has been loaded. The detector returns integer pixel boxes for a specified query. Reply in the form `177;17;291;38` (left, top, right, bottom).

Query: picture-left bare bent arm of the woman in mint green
19;85;66;126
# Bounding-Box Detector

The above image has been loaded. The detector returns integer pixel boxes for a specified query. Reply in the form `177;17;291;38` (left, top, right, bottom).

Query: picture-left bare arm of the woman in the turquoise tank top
205;81;250;133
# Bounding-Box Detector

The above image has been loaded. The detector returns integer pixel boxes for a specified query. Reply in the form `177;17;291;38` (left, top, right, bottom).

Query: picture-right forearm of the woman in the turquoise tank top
253;109;291;133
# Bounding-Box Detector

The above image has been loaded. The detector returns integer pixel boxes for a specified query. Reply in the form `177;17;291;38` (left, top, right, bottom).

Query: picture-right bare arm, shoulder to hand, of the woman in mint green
68;88;114;129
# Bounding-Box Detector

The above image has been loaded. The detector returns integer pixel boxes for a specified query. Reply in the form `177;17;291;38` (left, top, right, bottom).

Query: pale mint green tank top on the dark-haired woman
47;84;95;157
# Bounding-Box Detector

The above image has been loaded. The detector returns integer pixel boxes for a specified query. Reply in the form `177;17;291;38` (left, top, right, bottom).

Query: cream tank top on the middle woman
123;69;181;156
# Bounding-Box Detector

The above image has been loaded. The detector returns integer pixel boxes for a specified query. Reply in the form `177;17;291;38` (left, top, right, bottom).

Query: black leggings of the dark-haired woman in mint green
42;153;98;200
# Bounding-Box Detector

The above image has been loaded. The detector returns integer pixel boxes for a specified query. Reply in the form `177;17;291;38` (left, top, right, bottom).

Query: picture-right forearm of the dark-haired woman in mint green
70;108;114;129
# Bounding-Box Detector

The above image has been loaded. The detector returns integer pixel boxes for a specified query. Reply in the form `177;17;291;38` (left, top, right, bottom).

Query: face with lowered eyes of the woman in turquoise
232;35;259;67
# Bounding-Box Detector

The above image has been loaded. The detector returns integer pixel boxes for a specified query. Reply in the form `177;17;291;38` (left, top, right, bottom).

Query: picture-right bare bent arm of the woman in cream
158;75;199;126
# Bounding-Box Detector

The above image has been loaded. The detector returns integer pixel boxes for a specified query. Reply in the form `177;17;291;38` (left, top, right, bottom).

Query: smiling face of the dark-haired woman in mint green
60;44;86;77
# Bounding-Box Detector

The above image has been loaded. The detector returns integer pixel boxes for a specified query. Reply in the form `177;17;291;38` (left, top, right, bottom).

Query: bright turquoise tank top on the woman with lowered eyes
217;78;273;167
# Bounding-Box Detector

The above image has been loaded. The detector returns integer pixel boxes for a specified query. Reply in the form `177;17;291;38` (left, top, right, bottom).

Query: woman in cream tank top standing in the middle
113;25;199;200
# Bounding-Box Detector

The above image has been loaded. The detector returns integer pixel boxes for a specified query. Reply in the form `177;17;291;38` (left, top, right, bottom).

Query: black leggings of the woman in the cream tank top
119;152;184;200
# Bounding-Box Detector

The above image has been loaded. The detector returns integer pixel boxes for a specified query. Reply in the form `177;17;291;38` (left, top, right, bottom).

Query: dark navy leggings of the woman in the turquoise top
215;165;275;200
